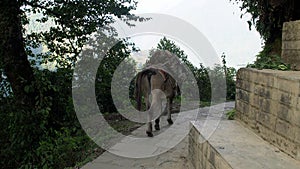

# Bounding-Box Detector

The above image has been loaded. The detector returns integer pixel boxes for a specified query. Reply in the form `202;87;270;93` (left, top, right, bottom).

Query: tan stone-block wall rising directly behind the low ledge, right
236;68;300;160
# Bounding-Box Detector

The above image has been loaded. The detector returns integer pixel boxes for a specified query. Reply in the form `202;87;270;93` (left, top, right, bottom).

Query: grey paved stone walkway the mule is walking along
82;102;234;169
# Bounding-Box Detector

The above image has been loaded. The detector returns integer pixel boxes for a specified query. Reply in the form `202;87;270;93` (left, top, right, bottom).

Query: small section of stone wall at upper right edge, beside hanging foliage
282;20;300;70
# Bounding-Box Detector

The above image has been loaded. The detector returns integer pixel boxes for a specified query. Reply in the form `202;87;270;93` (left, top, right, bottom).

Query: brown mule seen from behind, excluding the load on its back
135;68;178;137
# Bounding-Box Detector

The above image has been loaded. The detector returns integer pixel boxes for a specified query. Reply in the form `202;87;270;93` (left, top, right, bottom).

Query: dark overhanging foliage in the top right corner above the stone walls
230;0;300;45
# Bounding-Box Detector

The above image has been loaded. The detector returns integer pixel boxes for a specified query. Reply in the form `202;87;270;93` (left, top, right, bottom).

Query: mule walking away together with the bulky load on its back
135;50;182;137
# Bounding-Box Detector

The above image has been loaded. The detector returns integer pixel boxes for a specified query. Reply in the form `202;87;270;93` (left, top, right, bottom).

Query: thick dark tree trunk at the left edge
0;0;34;106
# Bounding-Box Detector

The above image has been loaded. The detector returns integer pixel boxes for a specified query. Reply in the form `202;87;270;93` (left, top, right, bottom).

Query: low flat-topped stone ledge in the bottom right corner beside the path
188;120;300;169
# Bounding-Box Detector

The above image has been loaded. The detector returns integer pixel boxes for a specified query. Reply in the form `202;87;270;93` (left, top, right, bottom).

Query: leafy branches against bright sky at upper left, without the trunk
22;0;140;67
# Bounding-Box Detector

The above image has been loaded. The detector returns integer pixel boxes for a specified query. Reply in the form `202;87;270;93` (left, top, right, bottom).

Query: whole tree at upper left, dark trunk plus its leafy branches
0;0;137;105
